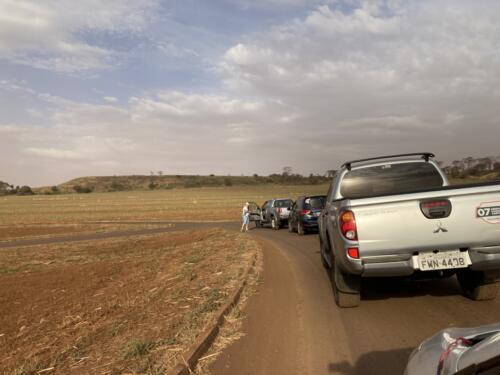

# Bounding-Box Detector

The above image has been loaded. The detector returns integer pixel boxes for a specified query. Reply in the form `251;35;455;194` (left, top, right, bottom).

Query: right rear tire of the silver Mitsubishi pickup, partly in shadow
457;269;498;301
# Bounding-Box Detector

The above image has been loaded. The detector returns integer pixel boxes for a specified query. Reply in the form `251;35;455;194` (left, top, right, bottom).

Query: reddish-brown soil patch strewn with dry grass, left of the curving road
0;229;258;375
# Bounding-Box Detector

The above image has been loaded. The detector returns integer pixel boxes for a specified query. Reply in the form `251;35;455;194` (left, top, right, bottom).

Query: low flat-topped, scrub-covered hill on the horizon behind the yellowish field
33;174;330;194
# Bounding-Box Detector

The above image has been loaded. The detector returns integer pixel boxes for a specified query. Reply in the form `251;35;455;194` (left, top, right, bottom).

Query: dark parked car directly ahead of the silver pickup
288;195;326;236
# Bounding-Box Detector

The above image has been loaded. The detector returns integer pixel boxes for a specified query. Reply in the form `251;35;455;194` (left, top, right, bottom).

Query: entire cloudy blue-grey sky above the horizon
0;0;500;186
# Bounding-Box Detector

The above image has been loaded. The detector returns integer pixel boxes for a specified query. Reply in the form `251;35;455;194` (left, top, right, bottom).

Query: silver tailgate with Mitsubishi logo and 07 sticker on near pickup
346;185;500;257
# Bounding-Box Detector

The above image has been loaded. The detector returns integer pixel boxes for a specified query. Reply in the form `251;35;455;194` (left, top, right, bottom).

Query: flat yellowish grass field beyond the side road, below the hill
0;185;328;228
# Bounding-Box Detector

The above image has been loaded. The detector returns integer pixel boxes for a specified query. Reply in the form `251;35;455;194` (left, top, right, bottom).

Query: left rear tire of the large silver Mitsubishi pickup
330;262;361;308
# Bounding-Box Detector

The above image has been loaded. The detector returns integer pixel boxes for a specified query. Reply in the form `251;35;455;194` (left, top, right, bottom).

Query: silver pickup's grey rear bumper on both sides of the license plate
348;246;500;277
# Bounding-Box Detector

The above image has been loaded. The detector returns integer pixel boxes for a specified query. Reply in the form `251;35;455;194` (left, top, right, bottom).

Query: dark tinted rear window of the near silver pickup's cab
340;162;443;199
